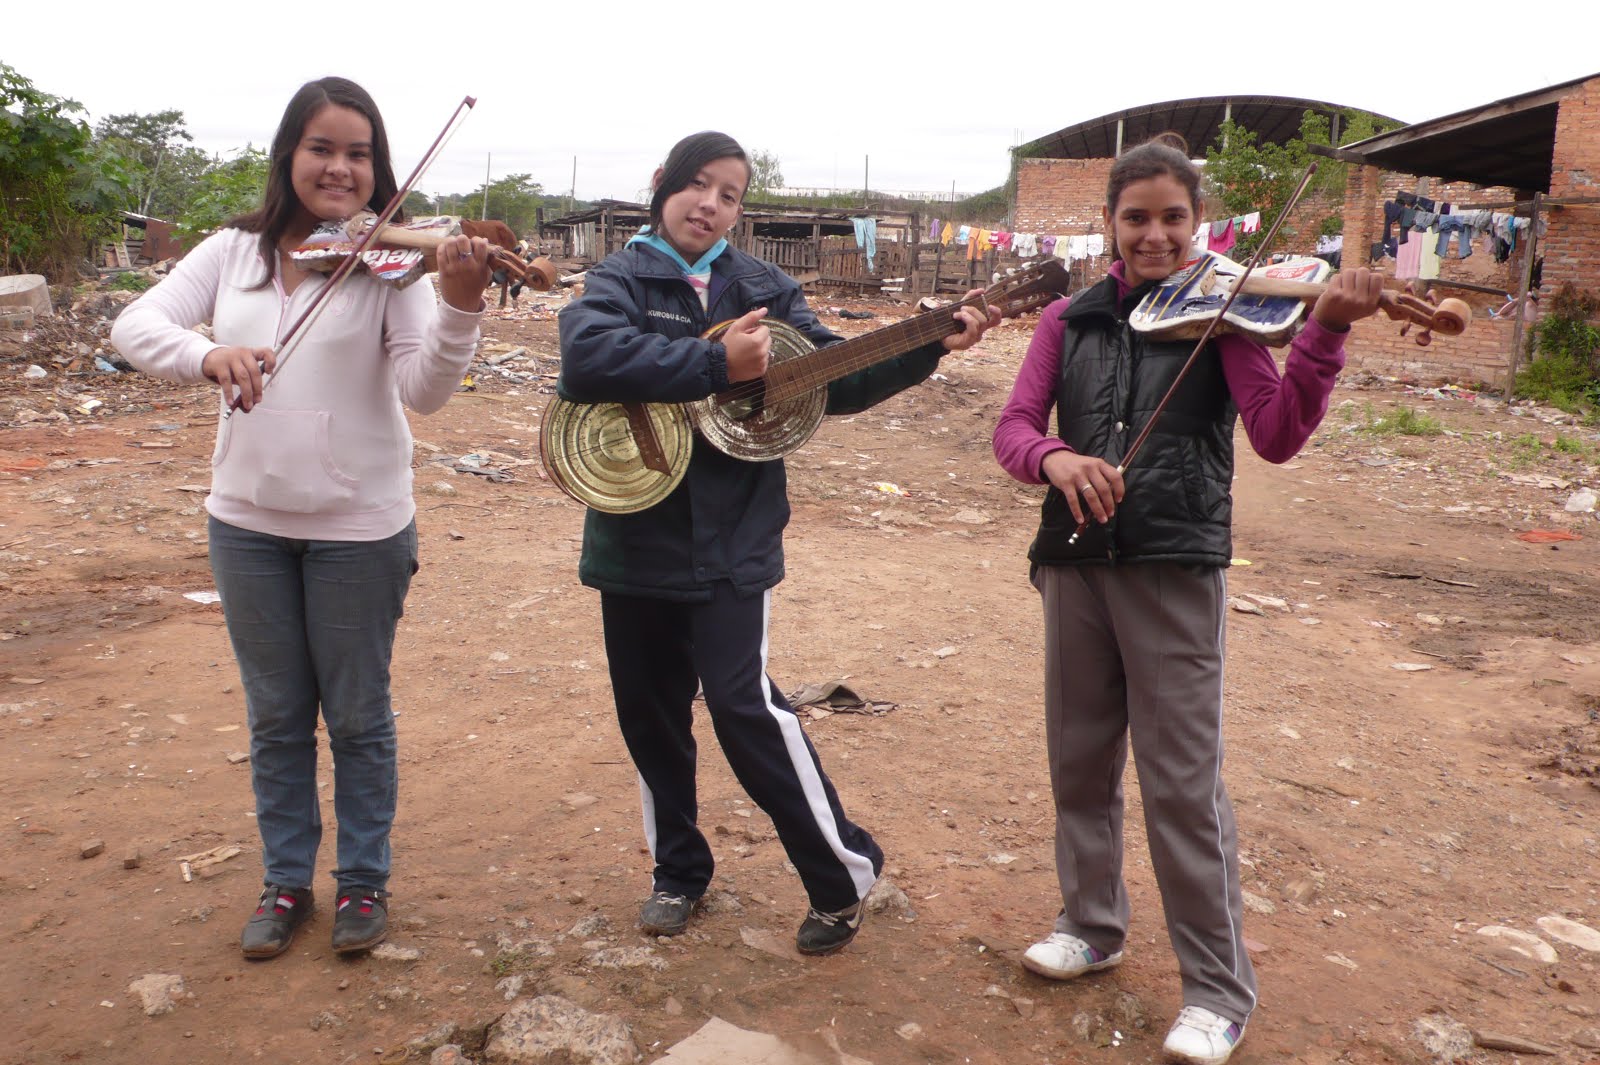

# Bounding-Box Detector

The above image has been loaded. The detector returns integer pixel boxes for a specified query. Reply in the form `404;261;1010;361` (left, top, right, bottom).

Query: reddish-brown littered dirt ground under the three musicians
0;284;1600;1065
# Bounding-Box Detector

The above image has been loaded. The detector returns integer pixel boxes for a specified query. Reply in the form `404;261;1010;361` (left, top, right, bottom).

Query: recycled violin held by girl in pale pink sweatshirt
290;211;557;293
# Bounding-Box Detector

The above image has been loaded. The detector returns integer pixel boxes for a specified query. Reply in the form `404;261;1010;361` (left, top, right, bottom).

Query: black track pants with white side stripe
600;584;883;911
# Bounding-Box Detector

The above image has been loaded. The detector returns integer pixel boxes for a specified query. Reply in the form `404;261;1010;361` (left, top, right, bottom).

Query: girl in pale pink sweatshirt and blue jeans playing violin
112;77;488;958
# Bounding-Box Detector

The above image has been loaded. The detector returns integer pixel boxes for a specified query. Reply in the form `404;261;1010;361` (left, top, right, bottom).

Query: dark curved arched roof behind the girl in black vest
1018;96;1398;158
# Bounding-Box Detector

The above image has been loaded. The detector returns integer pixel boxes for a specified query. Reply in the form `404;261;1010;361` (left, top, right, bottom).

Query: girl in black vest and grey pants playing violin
994;138;1381;1065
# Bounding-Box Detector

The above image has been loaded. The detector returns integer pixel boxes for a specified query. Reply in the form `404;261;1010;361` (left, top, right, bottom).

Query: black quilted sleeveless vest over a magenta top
1027;277;1238;566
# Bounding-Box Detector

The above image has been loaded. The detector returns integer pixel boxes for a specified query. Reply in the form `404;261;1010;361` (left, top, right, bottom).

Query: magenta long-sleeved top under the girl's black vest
994;262;1346;485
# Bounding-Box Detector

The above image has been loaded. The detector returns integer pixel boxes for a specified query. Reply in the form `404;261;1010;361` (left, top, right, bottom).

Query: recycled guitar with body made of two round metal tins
539;259;1067;513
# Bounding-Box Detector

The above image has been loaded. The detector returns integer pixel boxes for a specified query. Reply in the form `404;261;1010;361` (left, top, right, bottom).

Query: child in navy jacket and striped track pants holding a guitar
558;133;998;955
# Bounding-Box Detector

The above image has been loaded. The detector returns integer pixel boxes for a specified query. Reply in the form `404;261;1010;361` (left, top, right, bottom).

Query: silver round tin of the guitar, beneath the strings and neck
685;320;827;462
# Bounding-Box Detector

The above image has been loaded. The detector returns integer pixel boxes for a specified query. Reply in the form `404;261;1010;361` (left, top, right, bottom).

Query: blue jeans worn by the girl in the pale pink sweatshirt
208;518;416;892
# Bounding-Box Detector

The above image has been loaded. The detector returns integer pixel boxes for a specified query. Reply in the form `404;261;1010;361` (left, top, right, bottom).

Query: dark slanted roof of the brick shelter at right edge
1317;75;1600;192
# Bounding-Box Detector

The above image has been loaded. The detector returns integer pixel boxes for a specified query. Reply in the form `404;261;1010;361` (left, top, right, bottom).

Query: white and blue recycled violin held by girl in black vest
1128;253;1472;347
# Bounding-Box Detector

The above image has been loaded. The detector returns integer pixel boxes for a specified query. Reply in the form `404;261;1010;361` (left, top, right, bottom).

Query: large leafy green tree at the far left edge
0;62;123;281
